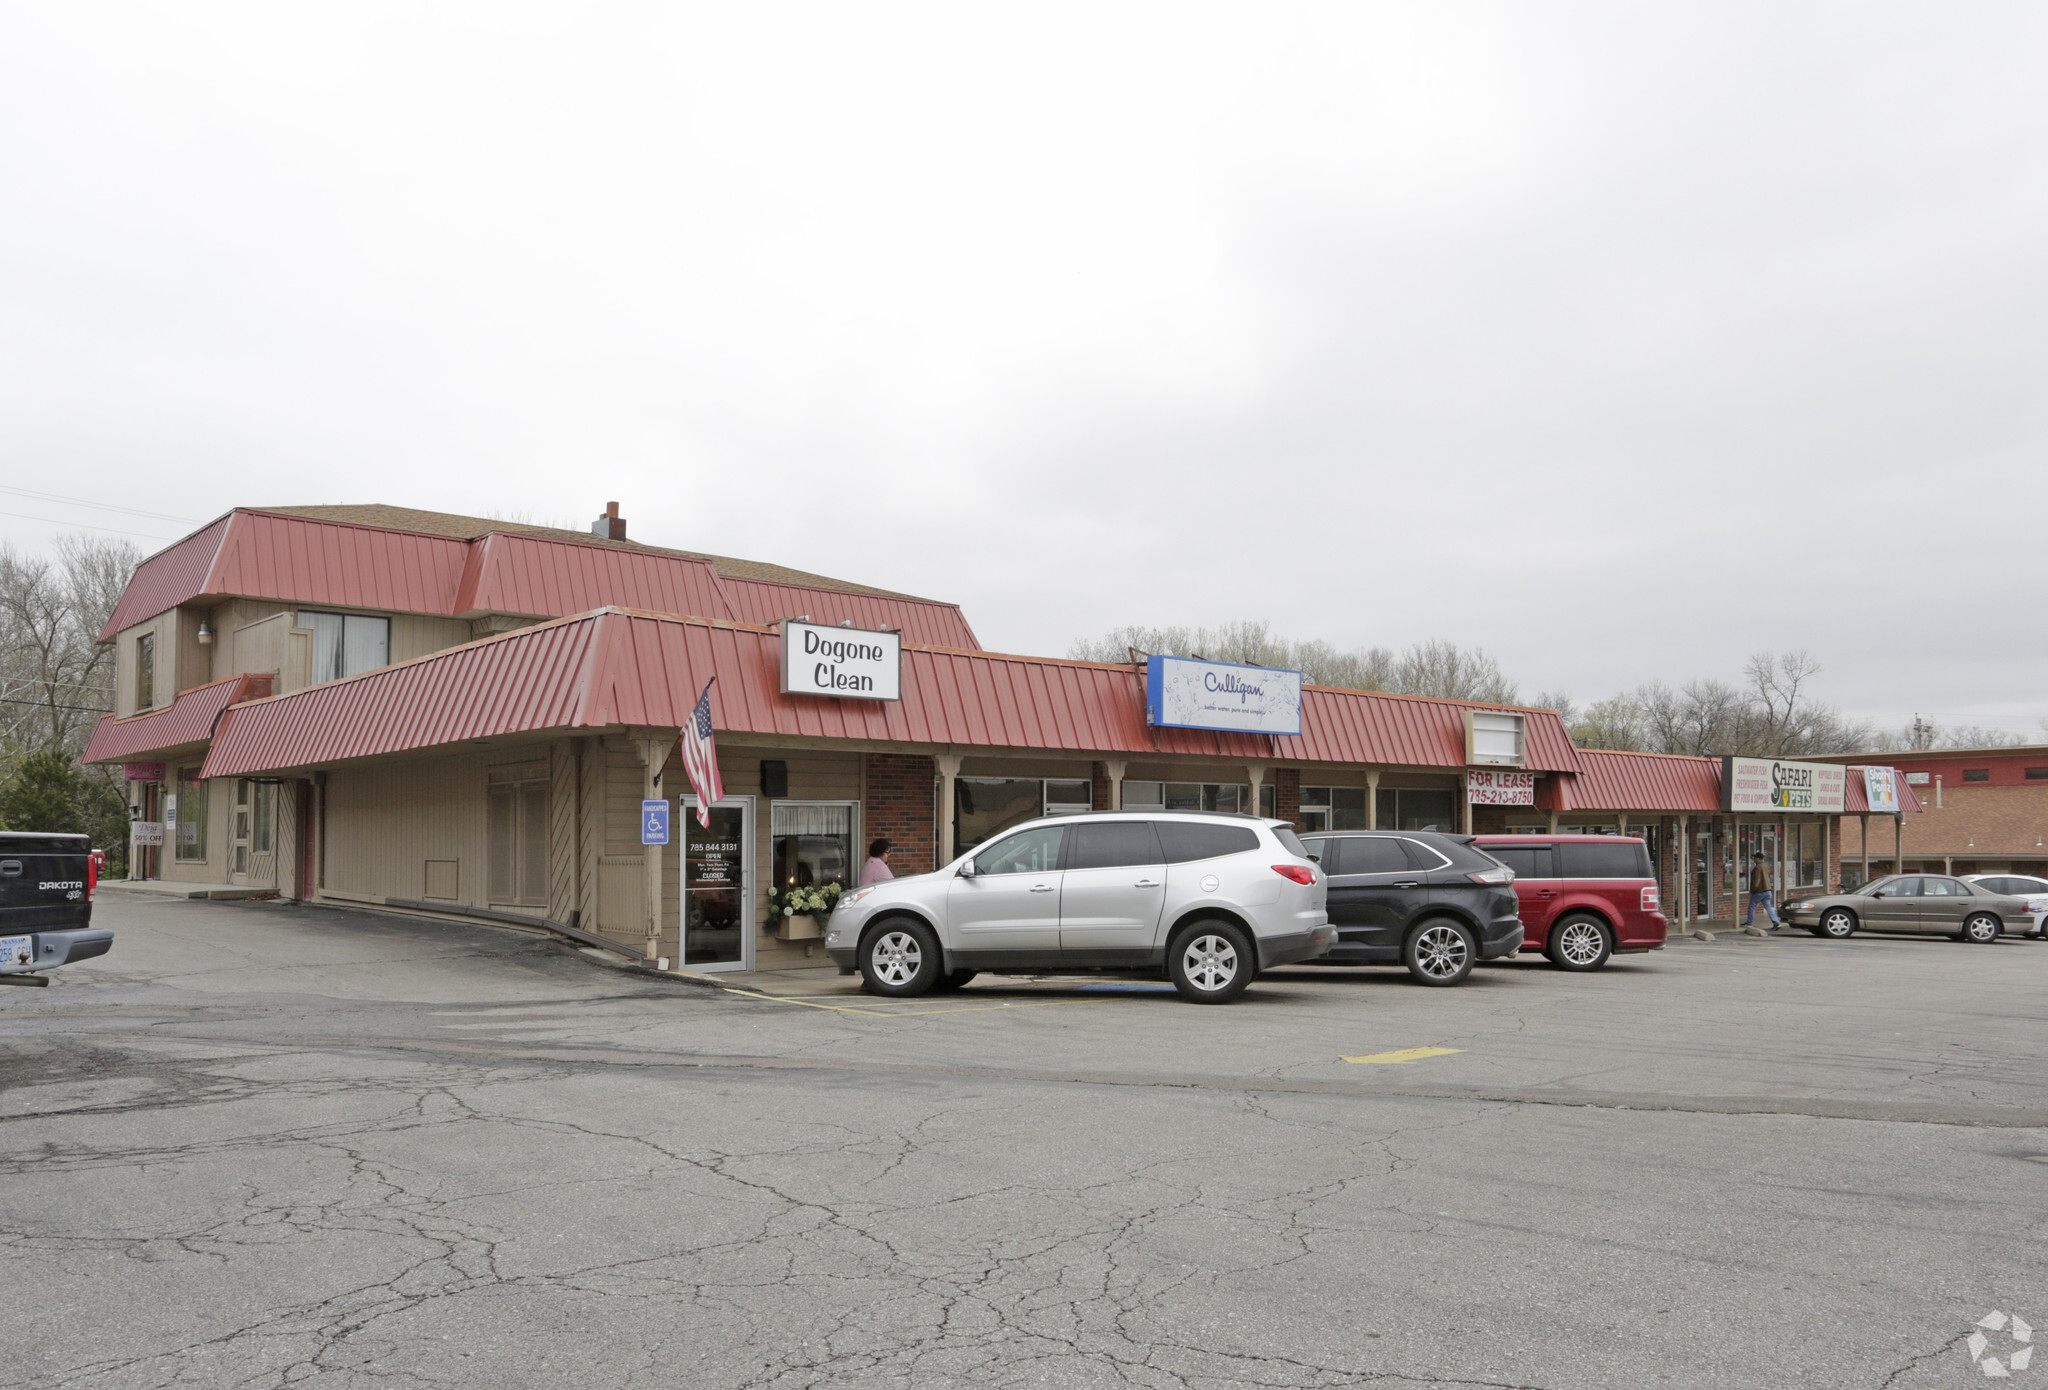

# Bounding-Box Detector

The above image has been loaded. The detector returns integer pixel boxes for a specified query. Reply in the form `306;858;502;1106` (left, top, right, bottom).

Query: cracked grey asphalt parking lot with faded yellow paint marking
0;895;2048;1390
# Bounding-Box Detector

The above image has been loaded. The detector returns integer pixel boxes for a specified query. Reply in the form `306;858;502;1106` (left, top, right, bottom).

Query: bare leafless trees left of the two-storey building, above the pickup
0;536;141;755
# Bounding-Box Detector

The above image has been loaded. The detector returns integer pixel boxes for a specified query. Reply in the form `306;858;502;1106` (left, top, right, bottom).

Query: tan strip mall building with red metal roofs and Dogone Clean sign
86;506;1917;970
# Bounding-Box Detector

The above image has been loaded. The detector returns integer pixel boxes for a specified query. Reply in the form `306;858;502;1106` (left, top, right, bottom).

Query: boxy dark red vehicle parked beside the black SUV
1475;835;1671;970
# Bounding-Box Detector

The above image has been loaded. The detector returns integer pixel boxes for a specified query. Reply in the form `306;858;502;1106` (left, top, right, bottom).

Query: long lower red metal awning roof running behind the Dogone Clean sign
207;608;1577;776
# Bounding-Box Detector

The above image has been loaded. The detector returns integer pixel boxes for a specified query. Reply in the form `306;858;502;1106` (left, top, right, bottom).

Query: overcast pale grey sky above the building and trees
0;0;2048;733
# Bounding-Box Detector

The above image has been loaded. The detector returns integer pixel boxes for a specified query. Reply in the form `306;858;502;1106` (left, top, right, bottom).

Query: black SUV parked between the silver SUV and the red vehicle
1300;831;1522;985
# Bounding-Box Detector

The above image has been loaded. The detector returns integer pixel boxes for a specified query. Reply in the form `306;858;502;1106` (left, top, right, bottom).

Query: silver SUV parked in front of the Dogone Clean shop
825;811;1335;1003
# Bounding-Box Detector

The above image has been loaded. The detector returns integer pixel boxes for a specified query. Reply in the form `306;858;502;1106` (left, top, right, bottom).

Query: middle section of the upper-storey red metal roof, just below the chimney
449;530;737;618
